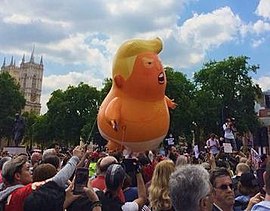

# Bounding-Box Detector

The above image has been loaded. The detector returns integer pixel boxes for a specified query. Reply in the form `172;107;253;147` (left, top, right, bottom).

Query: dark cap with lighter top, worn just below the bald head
105;164;126;190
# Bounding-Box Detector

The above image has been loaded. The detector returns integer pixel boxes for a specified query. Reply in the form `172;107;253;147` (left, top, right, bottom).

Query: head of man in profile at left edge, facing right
2;156;32;186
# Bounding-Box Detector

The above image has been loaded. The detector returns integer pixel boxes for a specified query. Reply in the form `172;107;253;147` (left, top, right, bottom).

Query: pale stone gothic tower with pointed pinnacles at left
1;49;43;114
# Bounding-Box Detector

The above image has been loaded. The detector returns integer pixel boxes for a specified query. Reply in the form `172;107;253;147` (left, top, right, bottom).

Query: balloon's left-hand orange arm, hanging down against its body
105;97;121;131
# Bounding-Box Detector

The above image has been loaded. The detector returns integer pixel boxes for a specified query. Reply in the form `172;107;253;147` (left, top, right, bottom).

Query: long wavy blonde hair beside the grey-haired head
149;160;175;210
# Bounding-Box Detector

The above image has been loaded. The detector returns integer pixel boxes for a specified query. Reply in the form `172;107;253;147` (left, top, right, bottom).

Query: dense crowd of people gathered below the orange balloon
0;129;270;211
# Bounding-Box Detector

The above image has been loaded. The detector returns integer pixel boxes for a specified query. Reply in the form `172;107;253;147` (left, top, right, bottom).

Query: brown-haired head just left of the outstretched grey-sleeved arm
33;163;57;182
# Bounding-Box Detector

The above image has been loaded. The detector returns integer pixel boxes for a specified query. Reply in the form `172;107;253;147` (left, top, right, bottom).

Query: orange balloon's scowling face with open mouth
124;52;167;100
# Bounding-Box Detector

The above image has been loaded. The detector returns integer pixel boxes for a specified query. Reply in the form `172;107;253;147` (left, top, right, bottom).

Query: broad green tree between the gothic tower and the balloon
47;83;100;144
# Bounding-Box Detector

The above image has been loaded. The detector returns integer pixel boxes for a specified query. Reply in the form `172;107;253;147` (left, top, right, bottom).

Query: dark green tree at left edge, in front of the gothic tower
0;72;26;139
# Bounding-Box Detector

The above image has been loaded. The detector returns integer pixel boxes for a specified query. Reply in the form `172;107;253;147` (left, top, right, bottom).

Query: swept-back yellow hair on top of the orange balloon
112;38;162;79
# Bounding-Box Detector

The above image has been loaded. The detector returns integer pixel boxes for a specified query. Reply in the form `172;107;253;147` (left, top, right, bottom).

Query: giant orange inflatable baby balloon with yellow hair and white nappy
97;38;176;152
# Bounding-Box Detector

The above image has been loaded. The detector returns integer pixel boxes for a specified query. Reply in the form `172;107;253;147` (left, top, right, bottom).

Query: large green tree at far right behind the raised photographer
194;56;261;139
